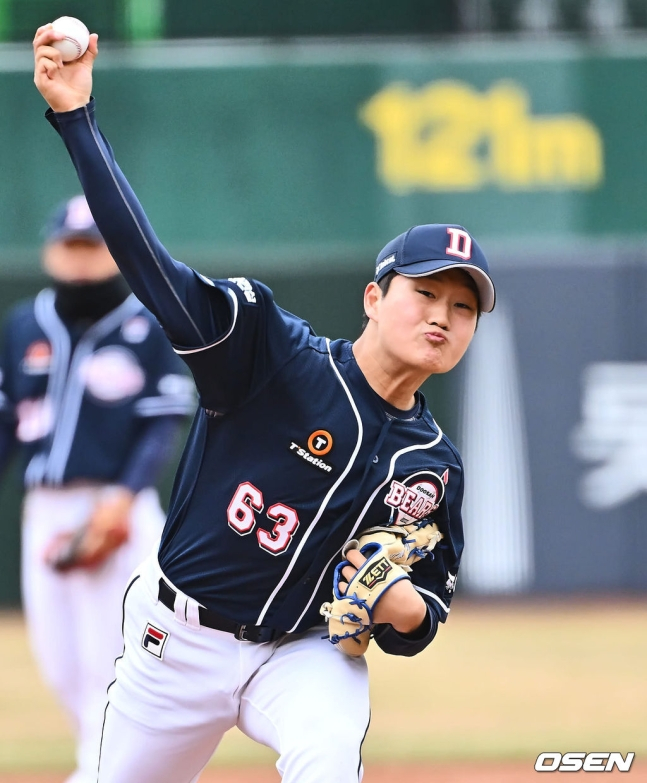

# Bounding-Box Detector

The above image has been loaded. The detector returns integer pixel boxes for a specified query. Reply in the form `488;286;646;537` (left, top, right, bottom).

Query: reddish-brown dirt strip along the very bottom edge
5;761;647;783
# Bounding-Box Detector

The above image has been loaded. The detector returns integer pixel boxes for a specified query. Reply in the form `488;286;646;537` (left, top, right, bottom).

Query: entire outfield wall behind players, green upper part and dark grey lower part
0;39;647;603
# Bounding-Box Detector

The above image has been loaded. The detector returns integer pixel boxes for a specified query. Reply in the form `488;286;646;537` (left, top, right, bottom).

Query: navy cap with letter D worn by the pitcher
375;223;496;313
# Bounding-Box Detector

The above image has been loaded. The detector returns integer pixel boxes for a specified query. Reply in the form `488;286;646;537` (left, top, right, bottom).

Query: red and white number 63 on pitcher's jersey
227;481;299;555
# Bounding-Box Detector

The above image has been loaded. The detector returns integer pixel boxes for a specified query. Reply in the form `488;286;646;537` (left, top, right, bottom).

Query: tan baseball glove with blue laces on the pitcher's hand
320;522;443;657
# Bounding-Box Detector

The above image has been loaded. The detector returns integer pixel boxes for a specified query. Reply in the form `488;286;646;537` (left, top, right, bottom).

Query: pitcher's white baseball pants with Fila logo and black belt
99;557;369;783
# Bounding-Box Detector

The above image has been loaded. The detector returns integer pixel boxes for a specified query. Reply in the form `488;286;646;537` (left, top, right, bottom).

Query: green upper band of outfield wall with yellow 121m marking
0;42;647;280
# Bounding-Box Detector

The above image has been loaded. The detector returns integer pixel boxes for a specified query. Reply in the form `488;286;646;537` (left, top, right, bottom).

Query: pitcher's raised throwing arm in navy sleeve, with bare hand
34;25;232;347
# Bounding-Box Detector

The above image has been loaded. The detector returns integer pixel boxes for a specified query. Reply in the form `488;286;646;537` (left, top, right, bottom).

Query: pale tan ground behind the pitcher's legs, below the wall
0;597;647;783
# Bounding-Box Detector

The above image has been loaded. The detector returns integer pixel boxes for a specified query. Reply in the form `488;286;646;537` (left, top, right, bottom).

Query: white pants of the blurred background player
22;487;164;783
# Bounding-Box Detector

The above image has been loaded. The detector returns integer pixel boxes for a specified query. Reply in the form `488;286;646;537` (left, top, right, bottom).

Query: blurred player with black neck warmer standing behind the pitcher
0;196;194;783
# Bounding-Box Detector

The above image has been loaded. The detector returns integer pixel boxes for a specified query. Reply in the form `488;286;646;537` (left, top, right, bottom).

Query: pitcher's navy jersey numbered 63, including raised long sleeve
48;102;463;654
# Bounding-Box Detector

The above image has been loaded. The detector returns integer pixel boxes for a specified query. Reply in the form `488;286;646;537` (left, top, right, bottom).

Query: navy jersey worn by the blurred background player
0;289;195;487
